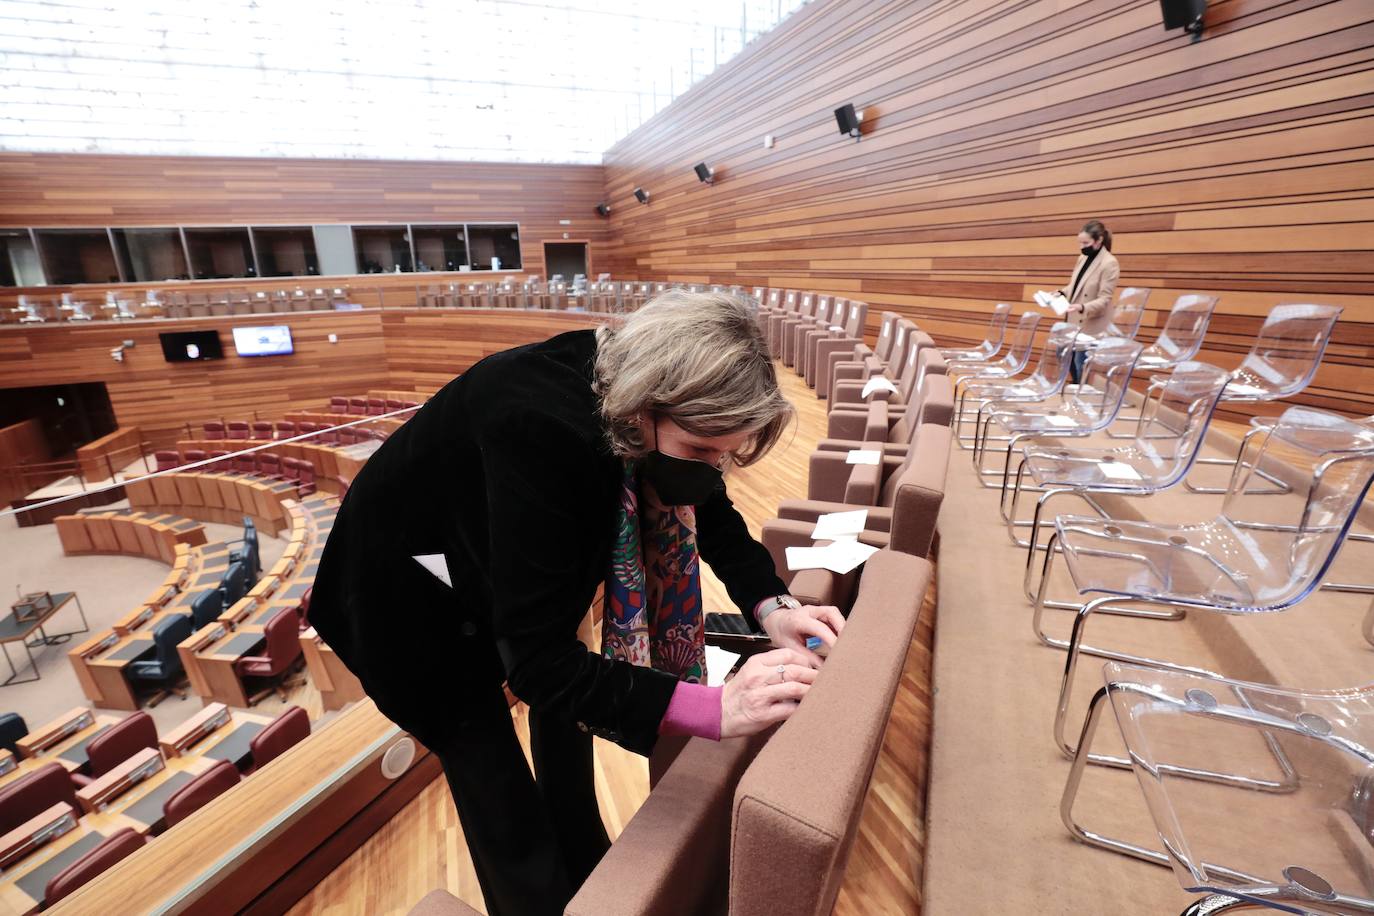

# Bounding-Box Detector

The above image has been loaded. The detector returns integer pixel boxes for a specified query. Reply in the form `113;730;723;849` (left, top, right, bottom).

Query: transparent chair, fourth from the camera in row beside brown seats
973;338;1142;489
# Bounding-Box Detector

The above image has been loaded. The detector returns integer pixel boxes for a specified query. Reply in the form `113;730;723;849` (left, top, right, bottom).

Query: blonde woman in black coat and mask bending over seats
311;291;844;913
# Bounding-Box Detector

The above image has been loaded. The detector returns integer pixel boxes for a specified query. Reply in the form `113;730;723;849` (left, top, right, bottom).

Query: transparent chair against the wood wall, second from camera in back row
1181;305;1342;493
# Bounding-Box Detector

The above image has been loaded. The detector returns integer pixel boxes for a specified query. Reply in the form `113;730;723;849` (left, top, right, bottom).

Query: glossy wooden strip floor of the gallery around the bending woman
291;364;936;916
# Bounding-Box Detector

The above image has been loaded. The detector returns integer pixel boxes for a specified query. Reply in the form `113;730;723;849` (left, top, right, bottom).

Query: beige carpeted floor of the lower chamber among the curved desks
0;501;286;732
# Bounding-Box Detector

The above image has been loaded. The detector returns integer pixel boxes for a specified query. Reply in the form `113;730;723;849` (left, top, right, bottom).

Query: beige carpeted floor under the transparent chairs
925;425;1374;916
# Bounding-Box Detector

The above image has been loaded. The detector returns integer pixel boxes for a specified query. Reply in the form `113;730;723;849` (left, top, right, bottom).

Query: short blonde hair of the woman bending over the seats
592;290;794;466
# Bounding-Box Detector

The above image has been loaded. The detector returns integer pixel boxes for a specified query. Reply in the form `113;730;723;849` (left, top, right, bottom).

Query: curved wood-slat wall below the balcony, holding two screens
0;309;599;445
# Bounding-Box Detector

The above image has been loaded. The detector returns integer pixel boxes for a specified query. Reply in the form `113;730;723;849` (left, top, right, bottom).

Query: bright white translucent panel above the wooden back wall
0;0;801;162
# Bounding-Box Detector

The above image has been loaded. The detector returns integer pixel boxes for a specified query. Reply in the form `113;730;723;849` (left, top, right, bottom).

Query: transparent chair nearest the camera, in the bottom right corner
1059;662;1374;915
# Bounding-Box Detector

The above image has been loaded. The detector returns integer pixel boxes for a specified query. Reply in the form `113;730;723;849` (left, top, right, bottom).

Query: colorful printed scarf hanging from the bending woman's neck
602;461;706;684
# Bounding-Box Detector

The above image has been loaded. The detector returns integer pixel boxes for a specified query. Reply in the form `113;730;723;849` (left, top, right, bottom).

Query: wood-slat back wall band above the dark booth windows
0;152;607;282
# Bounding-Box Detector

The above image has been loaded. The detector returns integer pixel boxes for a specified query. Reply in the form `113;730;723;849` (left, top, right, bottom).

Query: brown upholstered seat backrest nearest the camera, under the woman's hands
730;549;932;916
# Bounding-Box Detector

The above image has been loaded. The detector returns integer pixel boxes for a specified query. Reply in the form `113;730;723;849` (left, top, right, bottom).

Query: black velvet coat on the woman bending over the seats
311;331;786;754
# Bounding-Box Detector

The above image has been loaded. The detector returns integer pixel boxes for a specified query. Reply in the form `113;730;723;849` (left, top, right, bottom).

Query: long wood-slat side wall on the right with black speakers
603;0;1374;415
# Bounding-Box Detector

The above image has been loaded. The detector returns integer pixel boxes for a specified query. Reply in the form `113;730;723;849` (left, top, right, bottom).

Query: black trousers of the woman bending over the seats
433;687;610;916
